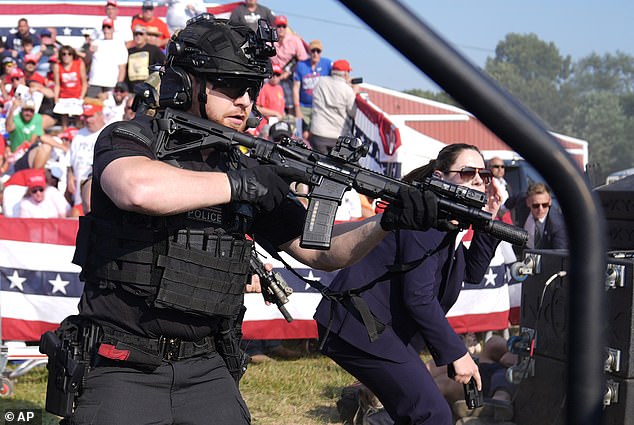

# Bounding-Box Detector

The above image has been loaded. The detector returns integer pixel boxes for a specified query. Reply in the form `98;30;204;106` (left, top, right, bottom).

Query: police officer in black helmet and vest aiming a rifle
48;15;436;425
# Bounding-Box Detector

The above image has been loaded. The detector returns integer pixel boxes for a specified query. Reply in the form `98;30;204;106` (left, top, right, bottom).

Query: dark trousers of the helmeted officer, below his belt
62;352;251;425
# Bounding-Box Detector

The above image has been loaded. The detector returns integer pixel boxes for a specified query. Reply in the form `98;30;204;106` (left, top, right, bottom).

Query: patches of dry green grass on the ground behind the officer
0;346;355;425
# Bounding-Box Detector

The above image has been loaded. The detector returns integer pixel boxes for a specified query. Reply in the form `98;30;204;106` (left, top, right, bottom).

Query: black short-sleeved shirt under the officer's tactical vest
79;115;306;341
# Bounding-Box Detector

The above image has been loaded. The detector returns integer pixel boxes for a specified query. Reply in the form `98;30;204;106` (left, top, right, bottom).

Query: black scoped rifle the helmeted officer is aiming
153;108;528;249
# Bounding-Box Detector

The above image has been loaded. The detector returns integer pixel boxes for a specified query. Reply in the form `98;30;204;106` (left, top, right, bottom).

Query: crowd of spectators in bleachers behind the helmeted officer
0;0;366;219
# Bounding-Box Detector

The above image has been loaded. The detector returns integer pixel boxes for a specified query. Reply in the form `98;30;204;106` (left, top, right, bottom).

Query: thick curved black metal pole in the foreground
340;0;606;425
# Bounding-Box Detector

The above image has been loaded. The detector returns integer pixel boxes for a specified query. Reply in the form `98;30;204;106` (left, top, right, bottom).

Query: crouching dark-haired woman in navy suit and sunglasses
315;144;500;425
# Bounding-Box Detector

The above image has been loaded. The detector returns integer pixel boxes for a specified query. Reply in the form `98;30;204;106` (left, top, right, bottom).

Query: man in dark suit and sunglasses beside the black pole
524;183;568;249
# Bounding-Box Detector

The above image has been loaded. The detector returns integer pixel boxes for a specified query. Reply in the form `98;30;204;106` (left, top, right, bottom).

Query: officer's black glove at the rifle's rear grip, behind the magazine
227;165;292;212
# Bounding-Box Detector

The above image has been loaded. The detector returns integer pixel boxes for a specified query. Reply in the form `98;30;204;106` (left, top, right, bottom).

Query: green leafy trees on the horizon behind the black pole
407;33;634;173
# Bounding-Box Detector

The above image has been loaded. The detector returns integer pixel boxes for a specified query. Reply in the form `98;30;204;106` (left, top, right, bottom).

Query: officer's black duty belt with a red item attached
98;325;216;366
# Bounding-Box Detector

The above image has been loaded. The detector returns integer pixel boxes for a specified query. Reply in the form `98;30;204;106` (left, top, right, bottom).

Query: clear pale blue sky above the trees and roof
260;0;634;91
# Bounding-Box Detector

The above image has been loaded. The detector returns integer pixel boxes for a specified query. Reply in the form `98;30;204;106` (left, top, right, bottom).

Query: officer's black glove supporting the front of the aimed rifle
381;187;438;231
